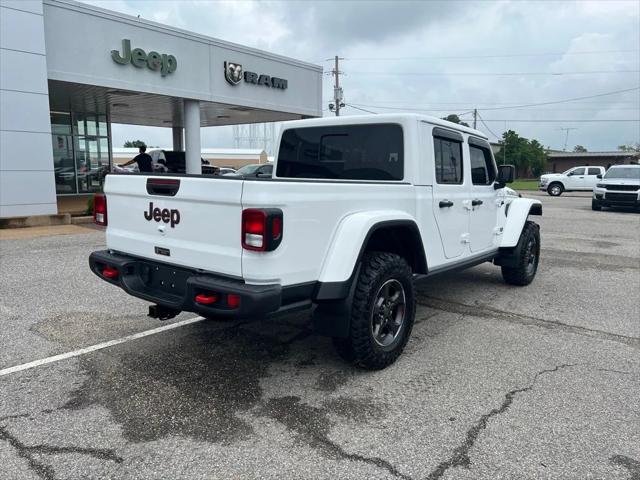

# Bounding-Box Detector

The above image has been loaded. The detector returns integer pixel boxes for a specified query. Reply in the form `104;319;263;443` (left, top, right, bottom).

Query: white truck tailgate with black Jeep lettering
104;175;244;277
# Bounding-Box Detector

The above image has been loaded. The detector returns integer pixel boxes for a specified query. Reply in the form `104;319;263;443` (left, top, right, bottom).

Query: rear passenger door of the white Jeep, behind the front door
433;127;471;258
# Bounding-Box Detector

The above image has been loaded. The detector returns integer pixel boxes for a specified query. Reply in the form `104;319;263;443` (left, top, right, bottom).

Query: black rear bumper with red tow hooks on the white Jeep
89;250;282;318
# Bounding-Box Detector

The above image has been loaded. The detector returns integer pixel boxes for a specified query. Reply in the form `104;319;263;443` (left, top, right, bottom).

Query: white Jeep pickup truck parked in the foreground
89;114;542;369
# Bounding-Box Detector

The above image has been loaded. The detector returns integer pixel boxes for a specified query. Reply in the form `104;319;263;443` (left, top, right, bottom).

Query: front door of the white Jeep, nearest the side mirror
469;142;498;253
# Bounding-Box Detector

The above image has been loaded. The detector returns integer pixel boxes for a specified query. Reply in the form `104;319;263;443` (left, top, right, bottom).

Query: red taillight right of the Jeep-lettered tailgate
242;208;282;252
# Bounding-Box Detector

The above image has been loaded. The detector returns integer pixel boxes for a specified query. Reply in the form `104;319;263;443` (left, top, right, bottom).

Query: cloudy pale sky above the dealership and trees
88;0;640;151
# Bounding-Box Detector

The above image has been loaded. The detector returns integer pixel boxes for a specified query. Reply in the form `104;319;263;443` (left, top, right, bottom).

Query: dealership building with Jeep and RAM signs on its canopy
0;0;322;218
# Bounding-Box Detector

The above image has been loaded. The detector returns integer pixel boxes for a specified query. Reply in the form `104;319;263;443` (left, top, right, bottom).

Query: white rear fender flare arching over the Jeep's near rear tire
313;210;426;300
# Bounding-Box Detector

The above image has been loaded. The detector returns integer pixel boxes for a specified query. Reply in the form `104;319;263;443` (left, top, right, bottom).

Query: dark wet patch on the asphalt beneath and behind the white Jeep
62;318;380;448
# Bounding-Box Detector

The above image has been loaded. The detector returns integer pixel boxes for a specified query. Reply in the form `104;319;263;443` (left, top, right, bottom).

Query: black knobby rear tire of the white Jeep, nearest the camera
334;252;416;370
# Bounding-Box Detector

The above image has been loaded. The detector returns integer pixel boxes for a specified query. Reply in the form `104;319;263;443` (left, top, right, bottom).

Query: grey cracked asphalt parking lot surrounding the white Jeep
0;195;640;480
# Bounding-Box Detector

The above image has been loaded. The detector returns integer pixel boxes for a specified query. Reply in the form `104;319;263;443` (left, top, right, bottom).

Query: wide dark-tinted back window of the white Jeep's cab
277;123;404;180
